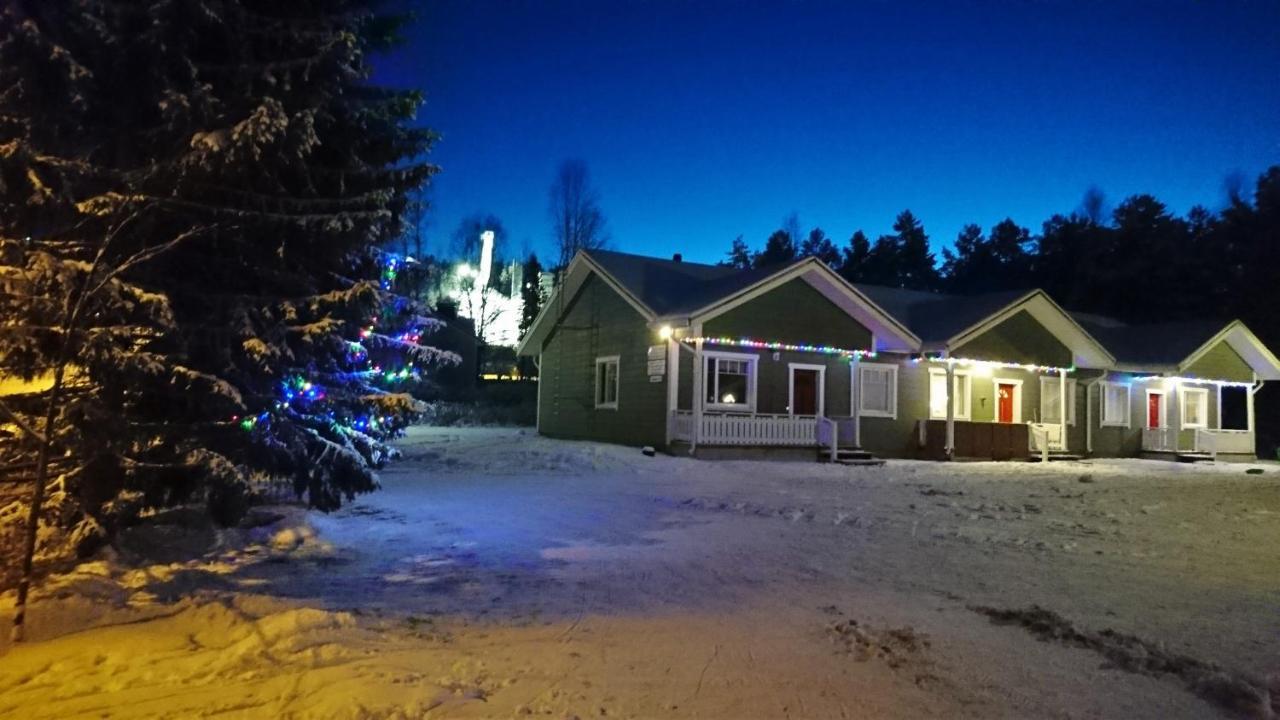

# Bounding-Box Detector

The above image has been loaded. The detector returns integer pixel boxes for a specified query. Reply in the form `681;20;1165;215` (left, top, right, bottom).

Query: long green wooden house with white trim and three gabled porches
518;245;1280;461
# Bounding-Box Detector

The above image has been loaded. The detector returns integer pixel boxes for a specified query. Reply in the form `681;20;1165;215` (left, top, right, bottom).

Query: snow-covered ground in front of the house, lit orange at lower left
0;428;1280;719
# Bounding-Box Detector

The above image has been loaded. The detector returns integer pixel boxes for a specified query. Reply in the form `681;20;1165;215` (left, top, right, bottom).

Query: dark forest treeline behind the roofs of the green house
722;165;1280;347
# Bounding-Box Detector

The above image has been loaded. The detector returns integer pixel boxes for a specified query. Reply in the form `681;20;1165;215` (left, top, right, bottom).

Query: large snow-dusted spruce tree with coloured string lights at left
0;0;452;548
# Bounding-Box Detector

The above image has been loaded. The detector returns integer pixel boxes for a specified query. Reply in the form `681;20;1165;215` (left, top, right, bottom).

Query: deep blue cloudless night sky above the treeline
376;0;1280;261
